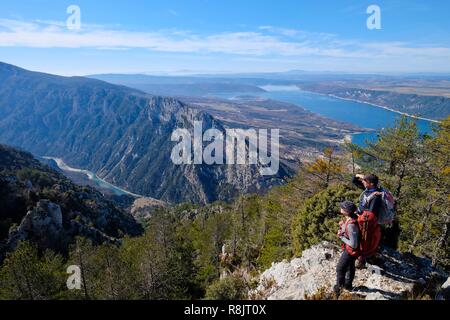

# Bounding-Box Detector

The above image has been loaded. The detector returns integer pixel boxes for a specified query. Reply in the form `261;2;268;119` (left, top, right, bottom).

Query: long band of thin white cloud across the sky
0;17;450;67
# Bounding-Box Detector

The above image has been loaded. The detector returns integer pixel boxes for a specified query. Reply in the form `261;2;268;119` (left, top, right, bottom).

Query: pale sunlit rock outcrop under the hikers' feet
251;242;446;300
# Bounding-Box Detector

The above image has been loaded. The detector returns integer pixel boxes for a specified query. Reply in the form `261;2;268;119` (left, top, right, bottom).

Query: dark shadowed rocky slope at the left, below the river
0;145;143;260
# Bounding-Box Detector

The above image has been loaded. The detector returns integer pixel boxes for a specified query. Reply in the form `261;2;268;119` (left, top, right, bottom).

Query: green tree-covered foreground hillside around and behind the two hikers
0;118;450;299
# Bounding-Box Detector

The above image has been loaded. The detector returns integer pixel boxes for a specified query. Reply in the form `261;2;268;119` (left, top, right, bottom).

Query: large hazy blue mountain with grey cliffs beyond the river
0;63;288;203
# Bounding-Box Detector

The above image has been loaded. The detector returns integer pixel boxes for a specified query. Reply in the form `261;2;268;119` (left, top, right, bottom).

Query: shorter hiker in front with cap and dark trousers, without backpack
334;201;360;296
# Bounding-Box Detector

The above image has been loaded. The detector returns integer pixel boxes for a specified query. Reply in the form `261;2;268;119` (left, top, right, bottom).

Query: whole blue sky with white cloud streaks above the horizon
0;0;450;75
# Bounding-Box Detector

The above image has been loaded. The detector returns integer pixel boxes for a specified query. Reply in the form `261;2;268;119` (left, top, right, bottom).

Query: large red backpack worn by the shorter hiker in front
342;211;381;258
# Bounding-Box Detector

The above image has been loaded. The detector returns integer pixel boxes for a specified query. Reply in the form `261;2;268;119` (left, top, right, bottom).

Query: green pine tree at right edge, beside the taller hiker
401;118;450;267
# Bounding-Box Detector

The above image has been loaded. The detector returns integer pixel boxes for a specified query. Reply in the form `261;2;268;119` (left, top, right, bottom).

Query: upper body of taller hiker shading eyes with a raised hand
352;174;383;218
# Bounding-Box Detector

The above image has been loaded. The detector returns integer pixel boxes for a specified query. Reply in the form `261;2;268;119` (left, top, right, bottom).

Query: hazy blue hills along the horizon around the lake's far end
91;70;450;120
